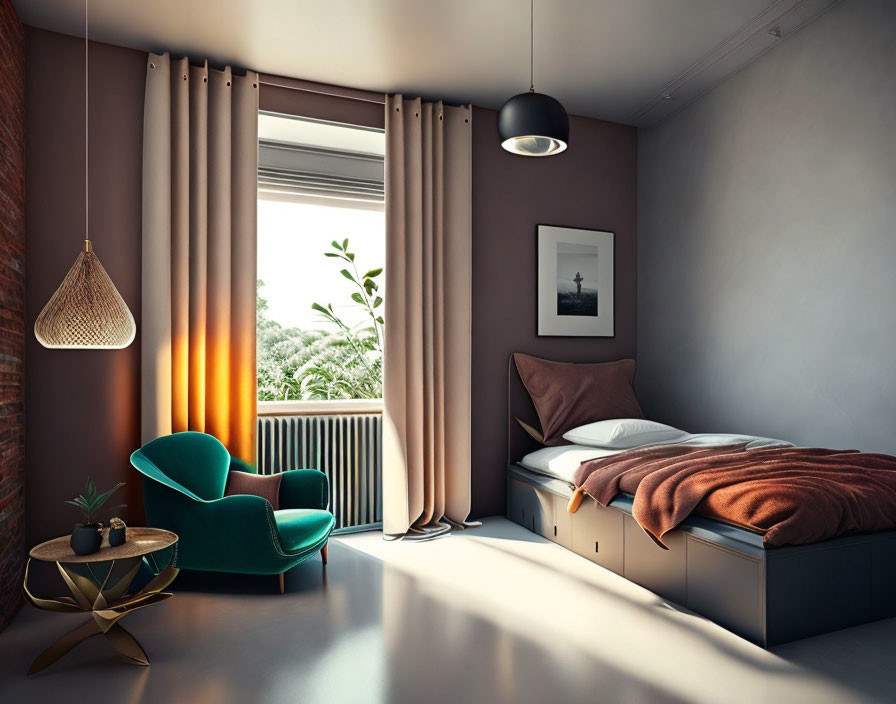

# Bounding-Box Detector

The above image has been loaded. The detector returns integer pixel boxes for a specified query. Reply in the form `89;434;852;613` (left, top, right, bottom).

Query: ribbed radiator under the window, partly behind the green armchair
257;413;383;530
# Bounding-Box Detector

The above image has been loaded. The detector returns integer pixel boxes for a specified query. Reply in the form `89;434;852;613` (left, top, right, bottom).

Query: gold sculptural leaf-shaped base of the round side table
23;529;178;675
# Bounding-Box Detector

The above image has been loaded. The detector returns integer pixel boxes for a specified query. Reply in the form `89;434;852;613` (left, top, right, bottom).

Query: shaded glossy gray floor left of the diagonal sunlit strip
0;541;696;704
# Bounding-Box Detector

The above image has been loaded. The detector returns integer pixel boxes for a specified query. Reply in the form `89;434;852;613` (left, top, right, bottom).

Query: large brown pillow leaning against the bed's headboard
513;352;644;445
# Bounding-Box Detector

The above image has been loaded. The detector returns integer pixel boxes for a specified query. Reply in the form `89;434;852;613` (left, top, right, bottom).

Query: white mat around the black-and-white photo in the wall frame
537;225;615;337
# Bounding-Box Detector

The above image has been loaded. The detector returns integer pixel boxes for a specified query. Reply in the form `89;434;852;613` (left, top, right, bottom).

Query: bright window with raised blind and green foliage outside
257;112;385;402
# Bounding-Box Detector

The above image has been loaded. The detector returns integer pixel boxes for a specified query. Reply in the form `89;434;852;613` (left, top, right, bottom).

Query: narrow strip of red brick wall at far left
0;0;25;628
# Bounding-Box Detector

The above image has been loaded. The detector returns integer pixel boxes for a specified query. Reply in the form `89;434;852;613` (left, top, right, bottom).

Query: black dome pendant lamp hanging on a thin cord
498;0;569;156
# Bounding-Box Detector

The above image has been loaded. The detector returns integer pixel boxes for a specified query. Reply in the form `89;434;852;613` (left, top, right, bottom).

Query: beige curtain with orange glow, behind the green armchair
141;54;258;464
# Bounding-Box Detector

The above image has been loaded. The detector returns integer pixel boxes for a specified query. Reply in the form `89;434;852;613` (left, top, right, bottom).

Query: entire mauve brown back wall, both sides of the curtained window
27;28;637;545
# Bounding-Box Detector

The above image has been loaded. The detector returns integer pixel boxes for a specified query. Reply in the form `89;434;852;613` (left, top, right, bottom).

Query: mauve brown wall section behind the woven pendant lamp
25;27;146;546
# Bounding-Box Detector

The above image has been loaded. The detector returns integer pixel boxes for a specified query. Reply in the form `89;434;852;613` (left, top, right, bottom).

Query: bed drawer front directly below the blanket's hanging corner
624;516;687;604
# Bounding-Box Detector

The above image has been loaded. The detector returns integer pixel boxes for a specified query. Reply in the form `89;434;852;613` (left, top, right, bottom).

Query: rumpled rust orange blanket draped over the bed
571;443;896;547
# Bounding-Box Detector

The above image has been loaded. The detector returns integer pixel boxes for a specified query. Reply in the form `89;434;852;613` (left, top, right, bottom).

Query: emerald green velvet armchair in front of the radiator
131;432;335;592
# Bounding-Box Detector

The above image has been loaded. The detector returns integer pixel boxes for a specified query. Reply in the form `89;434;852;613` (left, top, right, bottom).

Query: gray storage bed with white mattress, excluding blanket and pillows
507;354;896;647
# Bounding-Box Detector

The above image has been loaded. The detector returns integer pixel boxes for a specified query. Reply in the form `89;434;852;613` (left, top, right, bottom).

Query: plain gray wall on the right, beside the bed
637;0;896;452
